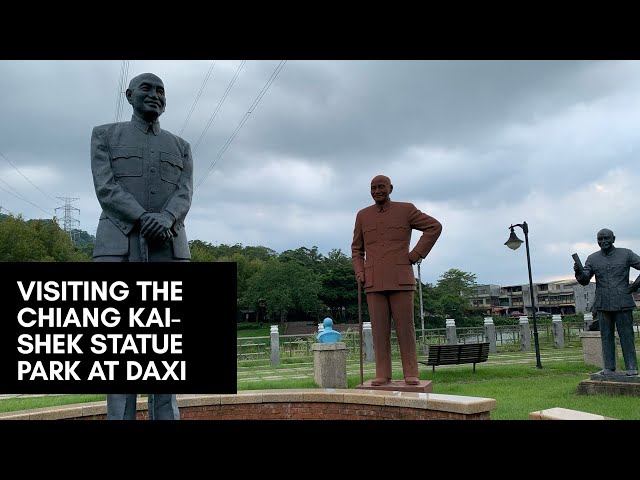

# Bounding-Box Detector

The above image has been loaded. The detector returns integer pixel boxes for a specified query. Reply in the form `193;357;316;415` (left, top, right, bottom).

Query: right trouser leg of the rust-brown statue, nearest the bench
389;290;418;378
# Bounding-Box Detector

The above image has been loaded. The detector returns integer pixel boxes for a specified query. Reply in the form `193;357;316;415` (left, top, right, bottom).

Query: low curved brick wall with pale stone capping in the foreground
0;389;496;420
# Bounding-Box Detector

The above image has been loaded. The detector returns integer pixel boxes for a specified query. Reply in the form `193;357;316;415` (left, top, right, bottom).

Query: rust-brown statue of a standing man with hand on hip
351;175;442;386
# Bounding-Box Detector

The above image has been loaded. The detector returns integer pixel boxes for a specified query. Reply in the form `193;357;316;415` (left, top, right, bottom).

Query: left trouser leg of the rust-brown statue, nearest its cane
367;292;392;378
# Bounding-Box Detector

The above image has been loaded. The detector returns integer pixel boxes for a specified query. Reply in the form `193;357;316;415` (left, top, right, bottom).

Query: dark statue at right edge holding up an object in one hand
573;228;640;375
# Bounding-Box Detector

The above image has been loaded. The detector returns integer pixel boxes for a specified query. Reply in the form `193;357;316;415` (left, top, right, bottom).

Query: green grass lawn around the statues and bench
0;347;640;420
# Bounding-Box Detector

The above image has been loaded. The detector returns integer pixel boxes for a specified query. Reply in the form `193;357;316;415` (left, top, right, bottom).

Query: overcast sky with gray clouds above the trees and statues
0;60;640;285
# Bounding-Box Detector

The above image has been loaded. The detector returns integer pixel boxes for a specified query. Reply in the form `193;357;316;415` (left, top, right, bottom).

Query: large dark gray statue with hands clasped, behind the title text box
91;73;193;420
